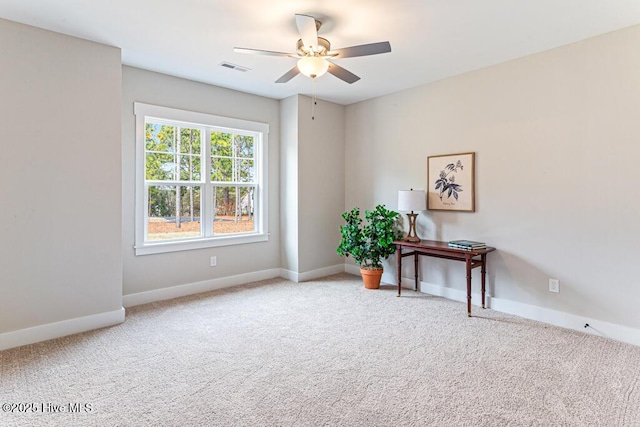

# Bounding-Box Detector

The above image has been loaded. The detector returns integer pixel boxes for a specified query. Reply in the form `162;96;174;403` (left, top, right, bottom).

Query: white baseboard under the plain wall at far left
0;307;125;351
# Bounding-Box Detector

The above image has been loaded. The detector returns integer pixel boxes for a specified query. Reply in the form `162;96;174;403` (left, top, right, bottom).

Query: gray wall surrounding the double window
122;66;280;295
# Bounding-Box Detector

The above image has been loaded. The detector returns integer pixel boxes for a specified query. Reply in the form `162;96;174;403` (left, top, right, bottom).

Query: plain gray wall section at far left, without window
0;19;122;334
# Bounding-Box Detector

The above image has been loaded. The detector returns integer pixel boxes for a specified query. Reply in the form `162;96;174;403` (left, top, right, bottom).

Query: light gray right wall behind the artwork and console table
346;26;640;328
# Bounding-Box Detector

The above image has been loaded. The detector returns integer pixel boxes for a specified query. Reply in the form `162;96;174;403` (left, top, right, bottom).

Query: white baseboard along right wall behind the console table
416;277;640;346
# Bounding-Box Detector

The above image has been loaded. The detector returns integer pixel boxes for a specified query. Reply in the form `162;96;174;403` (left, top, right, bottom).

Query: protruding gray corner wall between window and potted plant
280;95;344;280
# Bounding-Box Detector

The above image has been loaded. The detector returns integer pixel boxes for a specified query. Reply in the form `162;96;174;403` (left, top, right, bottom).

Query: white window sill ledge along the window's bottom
134;233;269;256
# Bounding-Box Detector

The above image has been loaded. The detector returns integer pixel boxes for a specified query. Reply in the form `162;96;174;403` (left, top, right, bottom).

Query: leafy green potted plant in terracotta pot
336;205;402;289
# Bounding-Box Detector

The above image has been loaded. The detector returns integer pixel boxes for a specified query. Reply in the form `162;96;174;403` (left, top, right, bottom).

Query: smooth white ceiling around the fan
0;0;640;104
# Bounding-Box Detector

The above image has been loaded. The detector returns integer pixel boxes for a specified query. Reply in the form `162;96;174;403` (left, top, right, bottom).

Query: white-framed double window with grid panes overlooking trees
134;103;269;255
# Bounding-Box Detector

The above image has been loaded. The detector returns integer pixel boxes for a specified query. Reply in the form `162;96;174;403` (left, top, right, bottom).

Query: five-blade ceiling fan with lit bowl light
233;14;391;84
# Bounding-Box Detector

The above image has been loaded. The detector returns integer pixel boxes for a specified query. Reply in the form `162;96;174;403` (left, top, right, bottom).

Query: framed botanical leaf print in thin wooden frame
427;153;476;212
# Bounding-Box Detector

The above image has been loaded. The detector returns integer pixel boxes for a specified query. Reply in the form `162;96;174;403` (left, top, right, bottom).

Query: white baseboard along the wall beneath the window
122;268;281;307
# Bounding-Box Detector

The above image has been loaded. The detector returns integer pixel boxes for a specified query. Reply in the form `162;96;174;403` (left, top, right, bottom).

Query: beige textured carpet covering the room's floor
0;275;640;426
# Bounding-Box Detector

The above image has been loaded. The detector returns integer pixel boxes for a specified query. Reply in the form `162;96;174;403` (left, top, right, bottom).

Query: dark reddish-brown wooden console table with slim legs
393;240;496;316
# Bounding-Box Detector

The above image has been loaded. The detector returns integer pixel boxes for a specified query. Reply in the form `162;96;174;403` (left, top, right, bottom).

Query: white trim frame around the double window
133;102;269;255
